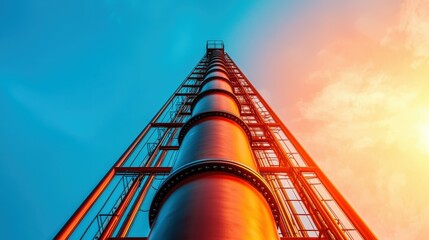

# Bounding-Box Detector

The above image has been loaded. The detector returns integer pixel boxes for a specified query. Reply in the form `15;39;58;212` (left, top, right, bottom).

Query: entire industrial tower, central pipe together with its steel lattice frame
55;41;376;240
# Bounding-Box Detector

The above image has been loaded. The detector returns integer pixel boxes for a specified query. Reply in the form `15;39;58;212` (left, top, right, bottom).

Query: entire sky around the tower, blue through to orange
0;0;429;239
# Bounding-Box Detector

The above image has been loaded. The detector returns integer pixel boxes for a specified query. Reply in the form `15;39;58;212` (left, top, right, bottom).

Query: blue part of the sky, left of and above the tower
0;0;296;239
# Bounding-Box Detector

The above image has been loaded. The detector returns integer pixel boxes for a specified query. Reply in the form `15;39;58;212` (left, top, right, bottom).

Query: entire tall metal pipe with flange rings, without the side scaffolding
149;50;278;240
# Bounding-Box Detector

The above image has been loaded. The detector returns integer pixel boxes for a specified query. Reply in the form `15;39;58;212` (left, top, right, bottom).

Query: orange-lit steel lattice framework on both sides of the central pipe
55;44;375;240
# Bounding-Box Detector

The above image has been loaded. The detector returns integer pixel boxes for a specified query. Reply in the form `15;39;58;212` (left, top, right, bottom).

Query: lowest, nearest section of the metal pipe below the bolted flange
149;173;278;240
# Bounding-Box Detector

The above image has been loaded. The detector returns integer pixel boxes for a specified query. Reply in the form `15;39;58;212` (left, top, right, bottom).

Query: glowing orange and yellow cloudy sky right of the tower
246;1;429;239
